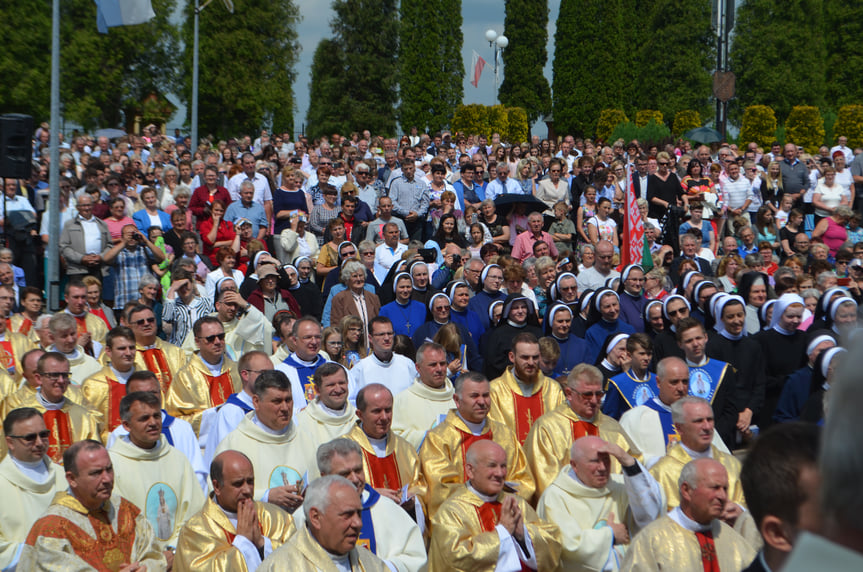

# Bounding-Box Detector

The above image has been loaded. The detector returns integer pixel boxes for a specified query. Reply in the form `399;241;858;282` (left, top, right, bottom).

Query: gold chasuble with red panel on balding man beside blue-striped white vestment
345;422;427;500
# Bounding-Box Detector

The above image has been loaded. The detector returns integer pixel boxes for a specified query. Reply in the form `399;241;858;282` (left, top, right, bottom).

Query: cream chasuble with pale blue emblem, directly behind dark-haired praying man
213;411;320;500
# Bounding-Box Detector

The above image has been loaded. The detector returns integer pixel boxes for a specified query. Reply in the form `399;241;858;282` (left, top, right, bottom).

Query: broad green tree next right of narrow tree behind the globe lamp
552;0;641;135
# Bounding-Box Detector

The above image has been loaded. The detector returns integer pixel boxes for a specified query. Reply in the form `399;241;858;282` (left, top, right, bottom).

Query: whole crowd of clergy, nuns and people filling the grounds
0;126;863;572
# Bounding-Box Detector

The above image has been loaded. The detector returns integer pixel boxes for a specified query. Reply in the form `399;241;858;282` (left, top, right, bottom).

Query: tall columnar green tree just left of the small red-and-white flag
399;0;464;132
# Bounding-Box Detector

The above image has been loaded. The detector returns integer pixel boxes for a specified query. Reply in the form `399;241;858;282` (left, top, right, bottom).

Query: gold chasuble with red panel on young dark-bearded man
488;366;565;444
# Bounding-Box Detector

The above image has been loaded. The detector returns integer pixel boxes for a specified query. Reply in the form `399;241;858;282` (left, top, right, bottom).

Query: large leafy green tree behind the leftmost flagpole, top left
0;0;178;129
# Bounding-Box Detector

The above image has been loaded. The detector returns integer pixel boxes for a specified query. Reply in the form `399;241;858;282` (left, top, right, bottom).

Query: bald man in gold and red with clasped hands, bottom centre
429;440;560;572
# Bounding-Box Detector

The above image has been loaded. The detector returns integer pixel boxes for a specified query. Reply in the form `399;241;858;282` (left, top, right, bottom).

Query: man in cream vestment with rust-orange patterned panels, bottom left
18;440;167;572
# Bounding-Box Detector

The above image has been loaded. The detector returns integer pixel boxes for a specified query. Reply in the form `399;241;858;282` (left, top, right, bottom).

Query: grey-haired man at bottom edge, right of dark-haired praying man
258;475;389;572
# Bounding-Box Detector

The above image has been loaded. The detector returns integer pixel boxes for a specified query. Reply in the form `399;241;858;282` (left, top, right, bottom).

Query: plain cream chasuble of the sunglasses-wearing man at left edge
0;457;69;570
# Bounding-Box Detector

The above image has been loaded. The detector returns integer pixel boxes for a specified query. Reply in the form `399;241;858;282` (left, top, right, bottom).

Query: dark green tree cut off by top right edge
823;0;863;108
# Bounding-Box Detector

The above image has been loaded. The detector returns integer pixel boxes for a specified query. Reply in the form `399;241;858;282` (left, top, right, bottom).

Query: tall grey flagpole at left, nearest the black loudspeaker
47;0;60;312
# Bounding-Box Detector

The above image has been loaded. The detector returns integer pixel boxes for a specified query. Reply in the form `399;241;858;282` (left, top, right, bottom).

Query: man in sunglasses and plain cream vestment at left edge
0;408;68;570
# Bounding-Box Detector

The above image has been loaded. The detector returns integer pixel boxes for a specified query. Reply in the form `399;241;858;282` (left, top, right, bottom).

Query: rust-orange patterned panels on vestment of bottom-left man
27;499;141;570
